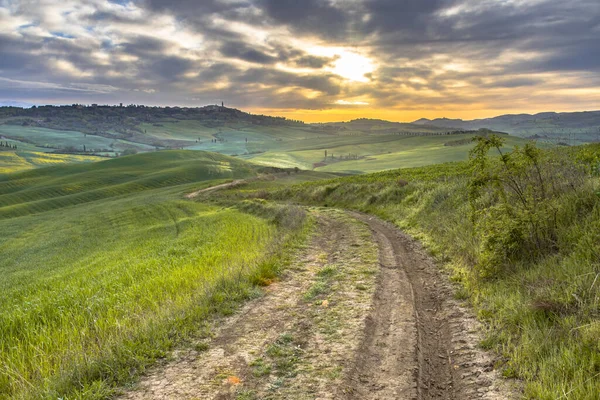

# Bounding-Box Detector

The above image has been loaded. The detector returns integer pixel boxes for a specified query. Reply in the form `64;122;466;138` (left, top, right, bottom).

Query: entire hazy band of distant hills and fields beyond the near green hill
0;105;544;174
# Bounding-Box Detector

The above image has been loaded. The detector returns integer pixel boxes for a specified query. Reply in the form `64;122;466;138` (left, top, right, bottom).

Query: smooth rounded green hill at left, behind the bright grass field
0;151;258;218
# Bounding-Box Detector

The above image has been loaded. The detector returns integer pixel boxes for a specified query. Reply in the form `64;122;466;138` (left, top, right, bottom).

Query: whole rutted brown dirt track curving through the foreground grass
124;211;516;400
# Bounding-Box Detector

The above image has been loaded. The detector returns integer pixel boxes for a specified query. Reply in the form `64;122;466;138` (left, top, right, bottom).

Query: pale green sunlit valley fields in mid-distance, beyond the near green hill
115;120;548;173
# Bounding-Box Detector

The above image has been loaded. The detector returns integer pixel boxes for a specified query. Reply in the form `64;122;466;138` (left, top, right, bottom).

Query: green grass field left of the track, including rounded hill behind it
0;151;310;399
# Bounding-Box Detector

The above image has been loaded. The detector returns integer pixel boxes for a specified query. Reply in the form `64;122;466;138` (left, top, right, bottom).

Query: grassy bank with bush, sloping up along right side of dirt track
221;145;600;400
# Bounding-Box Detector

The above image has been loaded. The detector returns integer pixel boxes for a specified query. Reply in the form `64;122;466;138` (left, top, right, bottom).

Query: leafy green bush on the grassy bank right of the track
469;135;585;276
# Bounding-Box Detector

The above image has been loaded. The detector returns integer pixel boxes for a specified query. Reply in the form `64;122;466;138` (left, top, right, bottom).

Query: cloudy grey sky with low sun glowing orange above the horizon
0;0;600;121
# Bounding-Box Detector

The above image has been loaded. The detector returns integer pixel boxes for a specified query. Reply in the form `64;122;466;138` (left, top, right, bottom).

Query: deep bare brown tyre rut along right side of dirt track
348;213;516;400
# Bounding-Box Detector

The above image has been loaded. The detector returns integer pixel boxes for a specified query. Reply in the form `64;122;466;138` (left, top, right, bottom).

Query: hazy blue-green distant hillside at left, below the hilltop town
0;105;310;155
